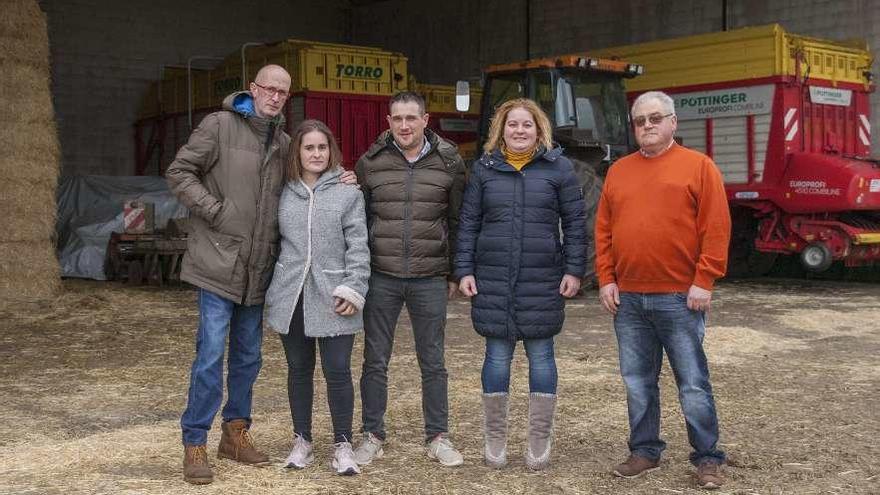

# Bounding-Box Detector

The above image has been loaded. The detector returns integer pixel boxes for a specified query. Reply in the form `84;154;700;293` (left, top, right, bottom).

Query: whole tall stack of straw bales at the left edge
0;0;61;303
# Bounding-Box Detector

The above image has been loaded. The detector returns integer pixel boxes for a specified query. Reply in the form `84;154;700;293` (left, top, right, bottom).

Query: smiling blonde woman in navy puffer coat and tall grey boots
455;98;587;469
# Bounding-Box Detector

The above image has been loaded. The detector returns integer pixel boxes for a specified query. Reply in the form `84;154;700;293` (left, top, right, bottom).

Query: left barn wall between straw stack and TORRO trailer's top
40;0;349;175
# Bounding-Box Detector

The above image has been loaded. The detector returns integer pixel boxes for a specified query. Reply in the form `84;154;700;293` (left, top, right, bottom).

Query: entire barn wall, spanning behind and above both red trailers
39;0;880;175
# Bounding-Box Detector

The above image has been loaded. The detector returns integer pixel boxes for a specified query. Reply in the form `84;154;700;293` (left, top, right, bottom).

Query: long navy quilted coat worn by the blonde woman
455;147;587;340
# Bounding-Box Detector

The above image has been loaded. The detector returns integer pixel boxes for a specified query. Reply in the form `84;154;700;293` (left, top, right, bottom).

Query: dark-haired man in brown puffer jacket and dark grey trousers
355;92;465;466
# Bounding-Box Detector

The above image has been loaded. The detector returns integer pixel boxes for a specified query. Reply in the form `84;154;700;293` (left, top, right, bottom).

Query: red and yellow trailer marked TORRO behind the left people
135;39;408;175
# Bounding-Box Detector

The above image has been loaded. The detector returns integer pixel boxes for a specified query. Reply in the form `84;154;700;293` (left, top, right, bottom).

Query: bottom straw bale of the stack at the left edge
0;239;61;303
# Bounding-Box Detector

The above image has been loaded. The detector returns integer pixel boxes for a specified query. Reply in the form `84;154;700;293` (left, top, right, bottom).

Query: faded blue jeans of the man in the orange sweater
614;292;724;465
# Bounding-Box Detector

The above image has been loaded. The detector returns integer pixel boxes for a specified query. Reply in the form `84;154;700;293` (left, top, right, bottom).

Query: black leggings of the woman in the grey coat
281;298;354;443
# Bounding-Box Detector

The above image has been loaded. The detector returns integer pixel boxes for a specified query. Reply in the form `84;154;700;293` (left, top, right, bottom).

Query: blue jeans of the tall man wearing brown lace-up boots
180;289;263;445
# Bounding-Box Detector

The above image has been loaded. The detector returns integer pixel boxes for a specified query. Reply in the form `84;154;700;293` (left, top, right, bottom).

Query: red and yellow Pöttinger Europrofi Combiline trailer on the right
599;24;880;274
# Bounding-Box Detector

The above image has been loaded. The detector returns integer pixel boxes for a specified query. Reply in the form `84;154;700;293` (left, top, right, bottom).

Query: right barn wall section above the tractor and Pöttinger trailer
352;0;880;150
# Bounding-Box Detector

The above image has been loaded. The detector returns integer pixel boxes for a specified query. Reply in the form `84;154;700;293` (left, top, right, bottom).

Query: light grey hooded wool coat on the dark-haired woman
265;169;370;337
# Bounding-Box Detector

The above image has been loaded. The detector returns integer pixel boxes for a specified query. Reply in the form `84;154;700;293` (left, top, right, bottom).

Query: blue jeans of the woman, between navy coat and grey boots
481;337;558;394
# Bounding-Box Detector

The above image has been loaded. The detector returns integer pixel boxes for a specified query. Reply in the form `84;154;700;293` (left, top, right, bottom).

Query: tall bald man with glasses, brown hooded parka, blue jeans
166;65;290;484
